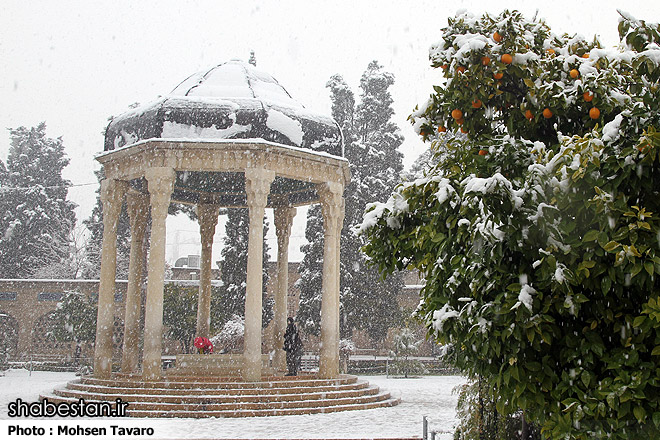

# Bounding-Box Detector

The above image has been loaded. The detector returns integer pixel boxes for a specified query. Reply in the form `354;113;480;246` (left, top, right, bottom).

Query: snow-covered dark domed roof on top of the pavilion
104;60;343;156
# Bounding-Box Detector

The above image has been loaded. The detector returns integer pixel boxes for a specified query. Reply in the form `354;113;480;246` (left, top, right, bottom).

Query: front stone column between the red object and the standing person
242;168;275;382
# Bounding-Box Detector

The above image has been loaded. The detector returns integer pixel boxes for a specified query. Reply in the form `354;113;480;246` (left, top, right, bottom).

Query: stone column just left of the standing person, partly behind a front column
273;206;296;371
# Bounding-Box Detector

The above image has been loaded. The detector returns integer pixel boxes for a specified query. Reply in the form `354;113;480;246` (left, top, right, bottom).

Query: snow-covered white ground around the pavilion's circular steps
0;370;465;440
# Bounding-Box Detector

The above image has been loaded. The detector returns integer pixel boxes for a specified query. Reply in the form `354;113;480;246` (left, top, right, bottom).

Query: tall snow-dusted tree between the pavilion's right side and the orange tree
298;61;403;342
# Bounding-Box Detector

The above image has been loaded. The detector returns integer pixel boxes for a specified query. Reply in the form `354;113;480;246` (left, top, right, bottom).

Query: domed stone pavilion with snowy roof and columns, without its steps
94;61;350;381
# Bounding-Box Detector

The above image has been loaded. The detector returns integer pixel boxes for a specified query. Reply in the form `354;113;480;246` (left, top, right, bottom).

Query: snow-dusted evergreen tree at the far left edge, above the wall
0;122;76;278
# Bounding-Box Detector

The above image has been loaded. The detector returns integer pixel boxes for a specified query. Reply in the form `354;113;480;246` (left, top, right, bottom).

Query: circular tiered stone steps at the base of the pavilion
40;374;399;418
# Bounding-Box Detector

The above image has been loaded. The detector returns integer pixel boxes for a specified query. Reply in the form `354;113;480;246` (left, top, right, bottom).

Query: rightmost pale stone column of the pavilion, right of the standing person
317;182;344;379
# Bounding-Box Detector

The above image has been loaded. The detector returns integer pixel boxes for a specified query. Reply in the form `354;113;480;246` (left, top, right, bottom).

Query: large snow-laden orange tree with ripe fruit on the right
359;11;660;439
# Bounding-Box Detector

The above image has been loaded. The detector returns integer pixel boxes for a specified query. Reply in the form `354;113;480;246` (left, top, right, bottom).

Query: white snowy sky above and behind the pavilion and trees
0;0;660;261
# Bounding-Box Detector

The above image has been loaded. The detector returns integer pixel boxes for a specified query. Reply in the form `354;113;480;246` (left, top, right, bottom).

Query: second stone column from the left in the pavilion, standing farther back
121;191;149;373
